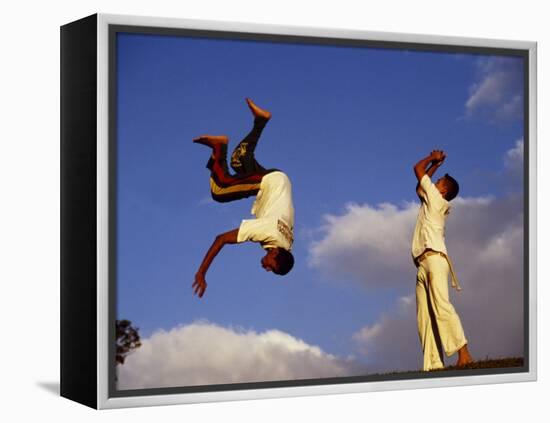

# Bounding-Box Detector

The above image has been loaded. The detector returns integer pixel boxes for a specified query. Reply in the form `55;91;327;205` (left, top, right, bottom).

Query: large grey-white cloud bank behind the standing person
309;141;524;371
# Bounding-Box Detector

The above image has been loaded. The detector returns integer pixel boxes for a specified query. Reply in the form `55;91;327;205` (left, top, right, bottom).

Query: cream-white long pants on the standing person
416;255;467;370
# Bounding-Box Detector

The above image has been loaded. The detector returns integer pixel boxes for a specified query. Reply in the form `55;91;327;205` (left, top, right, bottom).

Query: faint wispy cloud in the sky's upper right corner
465;56;523;121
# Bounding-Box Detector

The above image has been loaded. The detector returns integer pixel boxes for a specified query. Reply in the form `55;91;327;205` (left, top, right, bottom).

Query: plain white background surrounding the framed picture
0;0;550;423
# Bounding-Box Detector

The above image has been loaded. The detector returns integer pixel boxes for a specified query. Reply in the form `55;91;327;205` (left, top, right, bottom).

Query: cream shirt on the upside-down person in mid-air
237;171;294;251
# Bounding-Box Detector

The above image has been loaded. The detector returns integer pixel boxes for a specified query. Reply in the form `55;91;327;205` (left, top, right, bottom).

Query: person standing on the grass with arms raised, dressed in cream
412;150;473;370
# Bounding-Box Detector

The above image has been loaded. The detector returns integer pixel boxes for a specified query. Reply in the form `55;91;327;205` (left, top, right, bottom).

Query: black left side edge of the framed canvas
60;15;98;408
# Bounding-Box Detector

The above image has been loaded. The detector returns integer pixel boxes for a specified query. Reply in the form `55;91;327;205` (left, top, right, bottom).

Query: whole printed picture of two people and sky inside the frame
110;29;528;393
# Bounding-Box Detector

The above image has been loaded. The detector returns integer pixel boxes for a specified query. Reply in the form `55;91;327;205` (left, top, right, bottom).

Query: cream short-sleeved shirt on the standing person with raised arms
412;175;450;258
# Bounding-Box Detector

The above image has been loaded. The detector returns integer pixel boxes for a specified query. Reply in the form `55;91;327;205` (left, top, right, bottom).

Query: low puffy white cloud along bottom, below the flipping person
118;321;361;389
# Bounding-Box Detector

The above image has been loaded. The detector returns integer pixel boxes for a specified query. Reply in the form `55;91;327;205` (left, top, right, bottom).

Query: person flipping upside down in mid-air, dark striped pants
193;99;294;297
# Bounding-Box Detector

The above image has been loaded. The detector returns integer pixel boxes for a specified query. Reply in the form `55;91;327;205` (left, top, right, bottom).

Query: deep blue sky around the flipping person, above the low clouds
113;30;524;388
